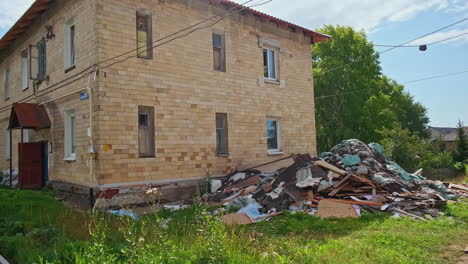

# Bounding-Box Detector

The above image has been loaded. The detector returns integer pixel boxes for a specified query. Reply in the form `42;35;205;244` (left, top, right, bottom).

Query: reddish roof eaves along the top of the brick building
0;0;331;51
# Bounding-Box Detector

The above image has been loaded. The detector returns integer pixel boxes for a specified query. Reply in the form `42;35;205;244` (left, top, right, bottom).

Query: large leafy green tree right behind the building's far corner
312;25;429;151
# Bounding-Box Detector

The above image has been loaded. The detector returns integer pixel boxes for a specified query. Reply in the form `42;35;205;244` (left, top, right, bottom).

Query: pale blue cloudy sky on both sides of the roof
0;0;468;126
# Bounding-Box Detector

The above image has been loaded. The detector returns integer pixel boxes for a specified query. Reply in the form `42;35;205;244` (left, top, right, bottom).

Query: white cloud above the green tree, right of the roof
234;0;458;32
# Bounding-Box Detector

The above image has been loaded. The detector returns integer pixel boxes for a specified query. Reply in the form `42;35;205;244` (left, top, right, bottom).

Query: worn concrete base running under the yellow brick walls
50;179;208;209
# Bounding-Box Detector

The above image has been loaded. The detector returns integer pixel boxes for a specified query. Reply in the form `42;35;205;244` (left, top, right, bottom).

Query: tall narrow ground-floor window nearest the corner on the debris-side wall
138;106;154;158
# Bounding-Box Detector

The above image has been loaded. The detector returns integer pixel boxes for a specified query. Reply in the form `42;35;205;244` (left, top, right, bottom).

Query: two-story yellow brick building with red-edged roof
0;0;330;206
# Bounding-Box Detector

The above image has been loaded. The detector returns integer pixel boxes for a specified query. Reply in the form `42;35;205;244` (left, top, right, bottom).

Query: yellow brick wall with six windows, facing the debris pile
97;0;315;184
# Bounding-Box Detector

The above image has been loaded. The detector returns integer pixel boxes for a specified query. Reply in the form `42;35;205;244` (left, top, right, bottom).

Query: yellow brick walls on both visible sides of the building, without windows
0;0;316;196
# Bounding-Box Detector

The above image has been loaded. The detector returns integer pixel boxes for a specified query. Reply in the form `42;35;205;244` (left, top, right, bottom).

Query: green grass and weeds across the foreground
0;188;468;264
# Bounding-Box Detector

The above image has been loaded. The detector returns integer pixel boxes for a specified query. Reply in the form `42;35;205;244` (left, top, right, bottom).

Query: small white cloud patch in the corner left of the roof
0;0;34;31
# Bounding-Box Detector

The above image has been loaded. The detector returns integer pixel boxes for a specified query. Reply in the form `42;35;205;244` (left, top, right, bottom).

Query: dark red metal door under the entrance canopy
18;142;43;189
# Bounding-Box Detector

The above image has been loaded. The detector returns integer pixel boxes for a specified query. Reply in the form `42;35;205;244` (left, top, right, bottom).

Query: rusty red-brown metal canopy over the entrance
8;103;50;129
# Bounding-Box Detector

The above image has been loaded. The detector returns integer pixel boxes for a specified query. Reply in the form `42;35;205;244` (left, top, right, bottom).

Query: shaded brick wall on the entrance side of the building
0;0;97;184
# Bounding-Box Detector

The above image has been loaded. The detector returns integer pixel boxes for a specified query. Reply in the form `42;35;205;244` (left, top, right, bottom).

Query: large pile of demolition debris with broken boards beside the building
206;139;468;224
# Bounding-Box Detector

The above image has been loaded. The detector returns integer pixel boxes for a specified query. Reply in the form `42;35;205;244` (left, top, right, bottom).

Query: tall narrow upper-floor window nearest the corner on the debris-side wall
136;10;153;59
